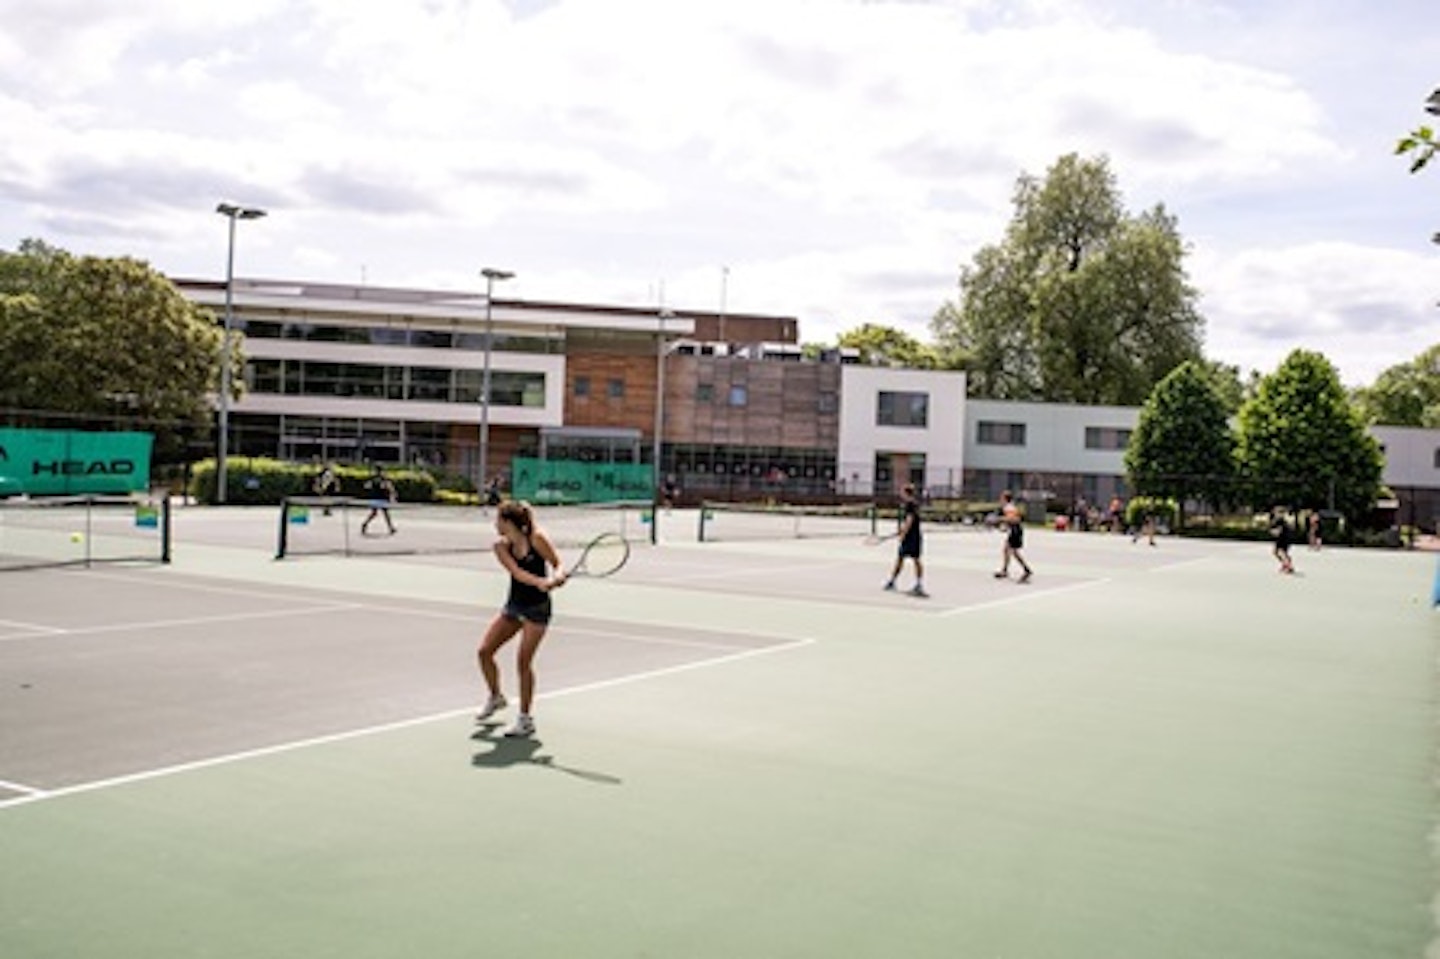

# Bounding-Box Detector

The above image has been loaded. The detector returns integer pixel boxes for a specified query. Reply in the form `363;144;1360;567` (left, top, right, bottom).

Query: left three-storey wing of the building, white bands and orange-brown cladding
176;279;798;480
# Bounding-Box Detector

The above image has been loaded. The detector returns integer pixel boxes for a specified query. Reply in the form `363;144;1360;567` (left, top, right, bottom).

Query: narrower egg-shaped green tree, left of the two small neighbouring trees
1125;361;1236;526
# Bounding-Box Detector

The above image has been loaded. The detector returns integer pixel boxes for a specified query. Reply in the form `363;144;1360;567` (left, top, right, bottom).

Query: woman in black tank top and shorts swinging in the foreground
475;500;569;736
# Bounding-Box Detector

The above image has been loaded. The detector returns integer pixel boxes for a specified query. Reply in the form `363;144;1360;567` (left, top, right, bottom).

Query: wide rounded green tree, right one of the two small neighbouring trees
1238;350;1384;521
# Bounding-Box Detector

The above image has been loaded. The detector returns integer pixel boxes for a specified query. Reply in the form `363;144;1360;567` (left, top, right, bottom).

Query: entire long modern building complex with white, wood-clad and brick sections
176;279;1440;528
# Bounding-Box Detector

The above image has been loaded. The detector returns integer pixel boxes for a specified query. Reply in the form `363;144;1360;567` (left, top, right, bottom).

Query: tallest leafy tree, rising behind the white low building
932;154;1202;406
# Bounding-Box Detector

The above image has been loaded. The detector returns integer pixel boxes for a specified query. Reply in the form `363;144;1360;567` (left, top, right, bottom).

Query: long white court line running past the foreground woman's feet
0;630;815;812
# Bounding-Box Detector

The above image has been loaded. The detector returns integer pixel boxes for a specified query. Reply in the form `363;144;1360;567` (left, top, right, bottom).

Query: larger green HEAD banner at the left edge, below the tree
0;428;156;495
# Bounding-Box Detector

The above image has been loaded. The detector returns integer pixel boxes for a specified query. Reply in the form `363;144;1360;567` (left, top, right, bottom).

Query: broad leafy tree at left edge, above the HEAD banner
0;240;227;457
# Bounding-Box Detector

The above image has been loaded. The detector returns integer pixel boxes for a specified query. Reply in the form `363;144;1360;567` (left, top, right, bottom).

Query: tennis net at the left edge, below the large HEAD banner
0;495;170;570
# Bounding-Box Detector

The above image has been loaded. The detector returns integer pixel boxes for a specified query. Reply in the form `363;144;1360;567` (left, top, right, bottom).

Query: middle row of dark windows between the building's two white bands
245;360;544;408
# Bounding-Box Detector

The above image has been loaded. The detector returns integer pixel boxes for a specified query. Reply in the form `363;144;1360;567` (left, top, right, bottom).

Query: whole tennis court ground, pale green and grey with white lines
0;511;1440;959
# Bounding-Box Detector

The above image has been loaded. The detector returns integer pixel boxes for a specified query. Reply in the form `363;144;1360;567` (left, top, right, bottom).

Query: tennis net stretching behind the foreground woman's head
275;497;652;559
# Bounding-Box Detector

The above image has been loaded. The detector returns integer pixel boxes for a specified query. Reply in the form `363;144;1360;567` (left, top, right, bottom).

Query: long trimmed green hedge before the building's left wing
190;456;439;505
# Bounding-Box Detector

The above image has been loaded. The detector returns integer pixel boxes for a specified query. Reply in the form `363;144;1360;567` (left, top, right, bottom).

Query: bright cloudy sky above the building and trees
0;0;1440;386
